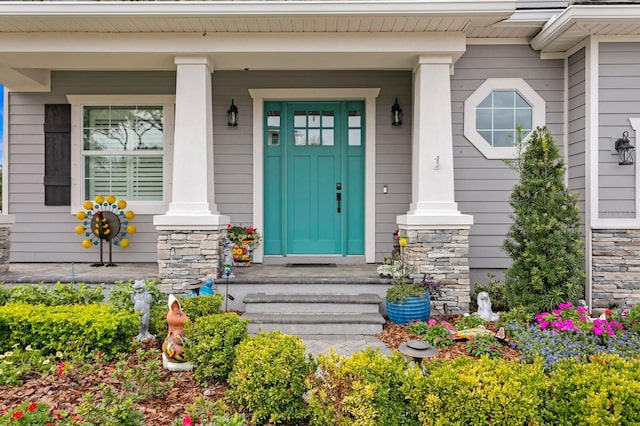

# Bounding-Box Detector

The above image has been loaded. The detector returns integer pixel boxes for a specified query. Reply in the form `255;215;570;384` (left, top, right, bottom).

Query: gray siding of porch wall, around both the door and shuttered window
8;71;412;263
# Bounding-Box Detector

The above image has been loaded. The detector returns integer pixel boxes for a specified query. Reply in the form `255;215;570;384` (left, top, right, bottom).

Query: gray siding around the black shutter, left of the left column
5;72;175;262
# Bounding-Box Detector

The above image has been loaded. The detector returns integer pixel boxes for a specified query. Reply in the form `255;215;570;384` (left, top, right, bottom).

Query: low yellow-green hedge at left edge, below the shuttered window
0;303;140;359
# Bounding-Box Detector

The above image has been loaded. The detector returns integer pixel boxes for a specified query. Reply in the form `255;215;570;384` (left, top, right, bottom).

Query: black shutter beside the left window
44;104;71;206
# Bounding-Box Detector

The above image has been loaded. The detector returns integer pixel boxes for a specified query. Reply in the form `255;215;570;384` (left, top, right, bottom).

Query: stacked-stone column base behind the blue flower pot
401;228;471;316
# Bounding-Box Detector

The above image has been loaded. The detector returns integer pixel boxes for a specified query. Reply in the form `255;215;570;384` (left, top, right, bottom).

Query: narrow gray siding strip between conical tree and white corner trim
567;49;586;230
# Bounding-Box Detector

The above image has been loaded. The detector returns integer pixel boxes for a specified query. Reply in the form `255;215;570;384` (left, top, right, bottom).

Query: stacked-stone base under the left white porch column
158;230;226;293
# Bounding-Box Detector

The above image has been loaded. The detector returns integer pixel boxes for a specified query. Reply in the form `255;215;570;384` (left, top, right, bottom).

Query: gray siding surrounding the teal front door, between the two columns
212;71;412;261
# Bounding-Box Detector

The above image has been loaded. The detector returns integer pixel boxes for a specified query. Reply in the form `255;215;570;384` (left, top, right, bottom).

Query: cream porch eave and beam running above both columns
0;0;541;91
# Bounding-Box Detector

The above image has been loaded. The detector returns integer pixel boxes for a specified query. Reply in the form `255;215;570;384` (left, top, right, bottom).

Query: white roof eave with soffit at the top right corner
531;4;640;51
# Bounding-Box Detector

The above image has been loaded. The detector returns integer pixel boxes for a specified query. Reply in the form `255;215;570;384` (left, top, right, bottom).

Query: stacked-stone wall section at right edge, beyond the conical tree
591;229;640;310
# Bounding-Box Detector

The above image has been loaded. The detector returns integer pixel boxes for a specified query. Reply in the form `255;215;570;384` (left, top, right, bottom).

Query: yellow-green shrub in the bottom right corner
544;355;640;425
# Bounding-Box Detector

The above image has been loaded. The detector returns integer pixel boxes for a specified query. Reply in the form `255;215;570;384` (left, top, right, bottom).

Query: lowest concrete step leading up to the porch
242;313;385;335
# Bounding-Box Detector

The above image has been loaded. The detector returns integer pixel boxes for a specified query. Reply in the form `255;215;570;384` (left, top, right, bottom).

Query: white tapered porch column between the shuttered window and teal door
154;57;229;230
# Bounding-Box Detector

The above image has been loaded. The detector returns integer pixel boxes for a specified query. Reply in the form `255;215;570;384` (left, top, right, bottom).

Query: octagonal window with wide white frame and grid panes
464;78;545;159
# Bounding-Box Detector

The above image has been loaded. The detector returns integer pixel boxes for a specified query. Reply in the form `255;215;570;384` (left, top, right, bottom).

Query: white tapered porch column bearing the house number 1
397;56;473;230
